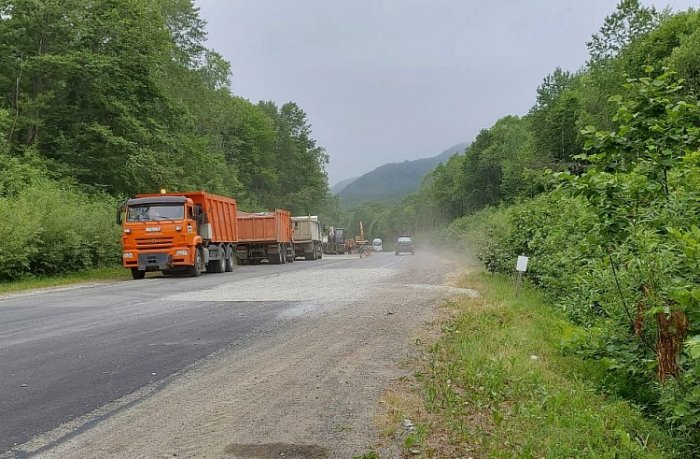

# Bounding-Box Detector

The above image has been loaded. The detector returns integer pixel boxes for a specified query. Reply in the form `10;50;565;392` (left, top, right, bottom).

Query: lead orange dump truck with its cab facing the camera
117;191;238;279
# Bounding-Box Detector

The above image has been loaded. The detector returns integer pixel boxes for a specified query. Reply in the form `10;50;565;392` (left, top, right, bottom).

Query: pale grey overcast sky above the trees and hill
196;0;698;184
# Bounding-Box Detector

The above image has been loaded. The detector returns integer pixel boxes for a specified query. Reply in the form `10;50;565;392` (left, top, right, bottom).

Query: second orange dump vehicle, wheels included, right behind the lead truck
236;209;294;264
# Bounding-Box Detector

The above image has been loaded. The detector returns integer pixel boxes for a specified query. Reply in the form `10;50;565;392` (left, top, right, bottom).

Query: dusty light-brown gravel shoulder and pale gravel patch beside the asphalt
19;253;474;458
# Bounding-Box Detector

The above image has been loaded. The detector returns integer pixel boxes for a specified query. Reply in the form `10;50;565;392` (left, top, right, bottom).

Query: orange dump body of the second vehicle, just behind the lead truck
238;209;292;244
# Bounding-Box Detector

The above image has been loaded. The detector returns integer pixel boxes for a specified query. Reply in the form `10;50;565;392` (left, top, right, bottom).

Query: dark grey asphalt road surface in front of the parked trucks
0;254;404;457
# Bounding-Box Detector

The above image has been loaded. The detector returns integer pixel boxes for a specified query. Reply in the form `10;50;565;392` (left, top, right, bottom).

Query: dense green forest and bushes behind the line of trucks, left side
0;0;335;281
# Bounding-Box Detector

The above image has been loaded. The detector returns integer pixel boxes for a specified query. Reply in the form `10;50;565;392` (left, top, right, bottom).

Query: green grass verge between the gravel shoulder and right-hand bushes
379;273;682;458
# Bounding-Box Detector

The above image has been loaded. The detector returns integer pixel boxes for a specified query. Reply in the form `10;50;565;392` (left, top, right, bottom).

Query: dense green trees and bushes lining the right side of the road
360;0;700;456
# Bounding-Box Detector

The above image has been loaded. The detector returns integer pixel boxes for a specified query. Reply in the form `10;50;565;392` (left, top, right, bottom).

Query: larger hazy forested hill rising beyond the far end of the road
336;143;468;207
